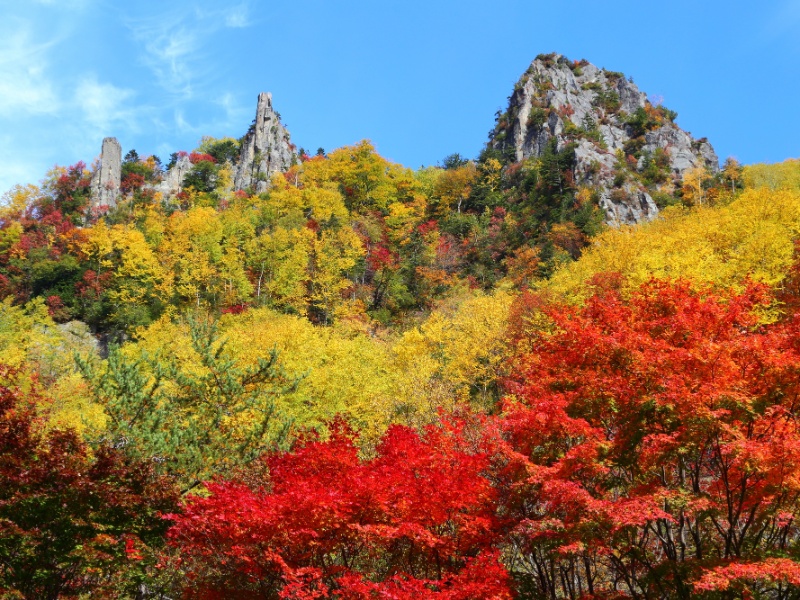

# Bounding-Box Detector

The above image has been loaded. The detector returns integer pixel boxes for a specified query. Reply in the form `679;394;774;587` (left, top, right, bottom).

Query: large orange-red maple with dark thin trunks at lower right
503;281;800;598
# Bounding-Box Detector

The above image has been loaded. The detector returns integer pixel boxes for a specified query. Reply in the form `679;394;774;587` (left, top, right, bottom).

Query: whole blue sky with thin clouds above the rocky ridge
0;0;800;193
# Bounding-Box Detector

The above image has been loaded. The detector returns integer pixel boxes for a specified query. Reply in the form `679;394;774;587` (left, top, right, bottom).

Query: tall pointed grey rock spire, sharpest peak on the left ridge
233;92;297;192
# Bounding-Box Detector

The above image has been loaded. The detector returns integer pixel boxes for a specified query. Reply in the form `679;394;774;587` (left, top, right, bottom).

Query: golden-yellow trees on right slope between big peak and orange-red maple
541;187;800;301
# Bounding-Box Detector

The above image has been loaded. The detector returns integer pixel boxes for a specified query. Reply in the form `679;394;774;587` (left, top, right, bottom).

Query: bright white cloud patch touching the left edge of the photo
0;28;59;116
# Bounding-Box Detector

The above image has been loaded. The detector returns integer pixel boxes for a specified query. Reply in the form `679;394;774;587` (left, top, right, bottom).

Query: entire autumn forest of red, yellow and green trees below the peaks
0;55;800;600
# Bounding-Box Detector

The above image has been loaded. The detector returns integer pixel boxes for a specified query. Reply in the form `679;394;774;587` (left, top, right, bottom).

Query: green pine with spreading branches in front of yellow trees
77;317;297;491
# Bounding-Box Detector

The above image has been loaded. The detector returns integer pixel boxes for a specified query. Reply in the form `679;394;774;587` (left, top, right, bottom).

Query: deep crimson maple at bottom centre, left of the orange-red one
170;427;510;600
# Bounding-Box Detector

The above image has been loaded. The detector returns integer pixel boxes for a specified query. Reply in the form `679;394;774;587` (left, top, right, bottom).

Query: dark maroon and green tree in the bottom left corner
0;367;178;599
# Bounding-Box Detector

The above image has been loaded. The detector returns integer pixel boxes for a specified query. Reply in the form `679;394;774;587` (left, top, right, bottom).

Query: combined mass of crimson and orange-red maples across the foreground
147;278;800;599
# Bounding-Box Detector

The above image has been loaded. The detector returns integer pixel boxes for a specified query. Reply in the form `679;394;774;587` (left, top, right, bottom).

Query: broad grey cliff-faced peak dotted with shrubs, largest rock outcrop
489;54;719;224
